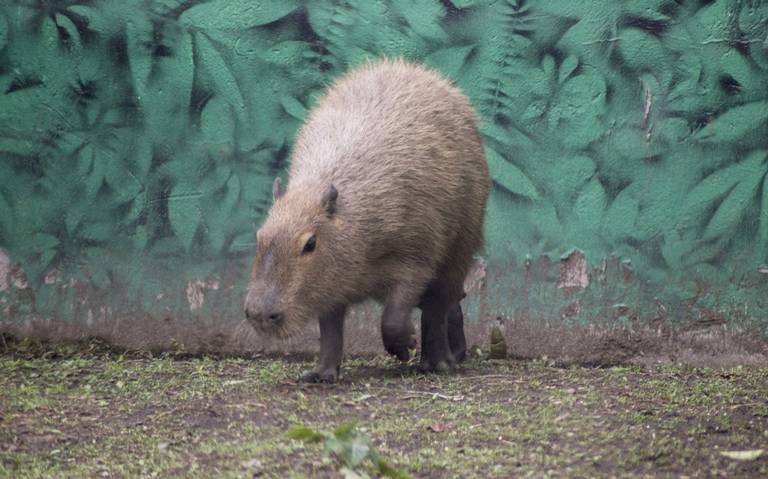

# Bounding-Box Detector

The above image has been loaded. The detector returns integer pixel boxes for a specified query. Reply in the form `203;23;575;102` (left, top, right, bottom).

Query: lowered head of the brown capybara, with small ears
245;178;338;338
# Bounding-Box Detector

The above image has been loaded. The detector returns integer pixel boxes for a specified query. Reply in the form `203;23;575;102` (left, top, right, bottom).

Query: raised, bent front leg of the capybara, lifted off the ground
381;288;417;361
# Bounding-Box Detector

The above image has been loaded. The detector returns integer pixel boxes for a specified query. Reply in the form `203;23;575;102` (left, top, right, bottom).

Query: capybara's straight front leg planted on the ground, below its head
299;307;346;383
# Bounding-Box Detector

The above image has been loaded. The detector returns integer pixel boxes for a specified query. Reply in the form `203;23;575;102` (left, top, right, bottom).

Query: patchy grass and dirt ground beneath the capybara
0;345;768;478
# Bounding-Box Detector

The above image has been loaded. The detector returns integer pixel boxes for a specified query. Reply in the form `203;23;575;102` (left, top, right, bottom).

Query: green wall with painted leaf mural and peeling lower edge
0;0;768;333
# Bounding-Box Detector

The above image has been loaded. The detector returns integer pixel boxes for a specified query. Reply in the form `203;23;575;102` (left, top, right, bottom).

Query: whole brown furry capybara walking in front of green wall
245;59;490;382
